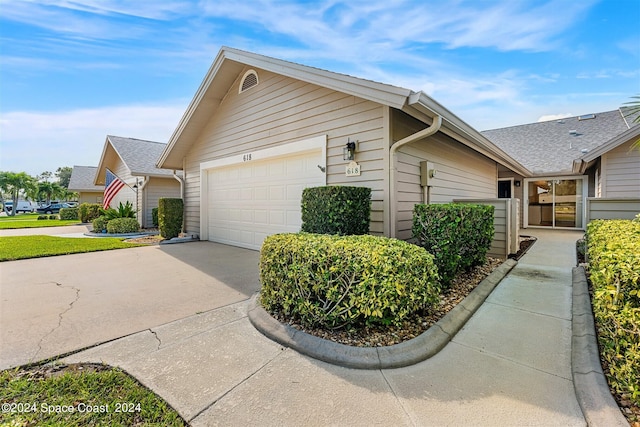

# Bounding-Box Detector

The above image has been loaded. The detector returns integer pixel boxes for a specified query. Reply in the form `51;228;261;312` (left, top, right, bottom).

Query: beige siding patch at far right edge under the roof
601;141;640;198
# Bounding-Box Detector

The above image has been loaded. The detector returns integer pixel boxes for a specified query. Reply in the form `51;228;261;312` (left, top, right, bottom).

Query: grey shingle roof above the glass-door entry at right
482;109;633;175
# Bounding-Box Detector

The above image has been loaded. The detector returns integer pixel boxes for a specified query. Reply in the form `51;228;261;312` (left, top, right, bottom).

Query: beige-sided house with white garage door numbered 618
157;47;530;249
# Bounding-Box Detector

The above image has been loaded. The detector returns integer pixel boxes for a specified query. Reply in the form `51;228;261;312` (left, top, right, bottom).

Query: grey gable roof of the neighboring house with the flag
94;135;173;184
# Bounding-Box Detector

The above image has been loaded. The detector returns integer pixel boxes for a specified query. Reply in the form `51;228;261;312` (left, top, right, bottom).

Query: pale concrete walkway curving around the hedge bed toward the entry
66;230;585;426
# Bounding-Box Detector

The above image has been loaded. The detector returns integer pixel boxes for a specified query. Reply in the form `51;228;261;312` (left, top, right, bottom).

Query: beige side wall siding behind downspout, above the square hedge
396;134;498;239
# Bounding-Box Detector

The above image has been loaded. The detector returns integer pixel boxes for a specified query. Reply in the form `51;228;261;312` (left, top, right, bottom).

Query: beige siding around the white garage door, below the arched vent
185;70;384;234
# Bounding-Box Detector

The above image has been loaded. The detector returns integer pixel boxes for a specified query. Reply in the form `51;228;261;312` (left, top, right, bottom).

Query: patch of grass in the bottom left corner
0;365;186;426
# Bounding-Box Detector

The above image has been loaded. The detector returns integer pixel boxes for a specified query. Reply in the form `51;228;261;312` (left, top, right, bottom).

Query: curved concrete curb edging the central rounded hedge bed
248;259;517;369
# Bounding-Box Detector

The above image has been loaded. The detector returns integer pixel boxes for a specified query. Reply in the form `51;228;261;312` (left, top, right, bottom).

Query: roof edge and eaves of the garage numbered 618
157;47;530;176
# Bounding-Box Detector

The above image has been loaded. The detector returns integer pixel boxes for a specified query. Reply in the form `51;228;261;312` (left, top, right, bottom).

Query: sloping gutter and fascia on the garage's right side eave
405;92;533;177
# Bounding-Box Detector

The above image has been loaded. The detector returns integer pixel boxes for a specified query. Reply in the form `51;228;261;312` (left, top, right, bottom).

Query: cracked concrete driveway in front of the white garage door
0;241;259;369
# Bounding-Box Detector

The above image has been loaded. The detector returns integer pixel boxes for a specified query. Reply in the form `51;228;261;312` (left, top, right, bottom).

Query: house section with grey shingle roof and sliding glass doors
482;109;640;229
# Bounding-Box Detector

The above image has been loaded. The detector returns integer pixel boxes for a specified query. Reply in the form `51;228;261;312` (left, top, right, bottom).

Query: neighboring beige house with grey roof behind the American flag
94;135;182;231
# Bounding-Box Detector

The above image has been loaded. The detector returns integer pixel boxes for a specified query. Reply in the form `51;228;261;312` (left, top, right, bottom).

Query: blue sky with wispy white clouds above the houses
0;0;640;175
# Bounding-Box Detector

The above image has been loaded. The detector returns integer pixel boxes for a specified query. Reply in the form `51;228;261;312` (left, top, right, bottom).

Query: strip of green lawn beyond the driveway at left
0;235;144;261
